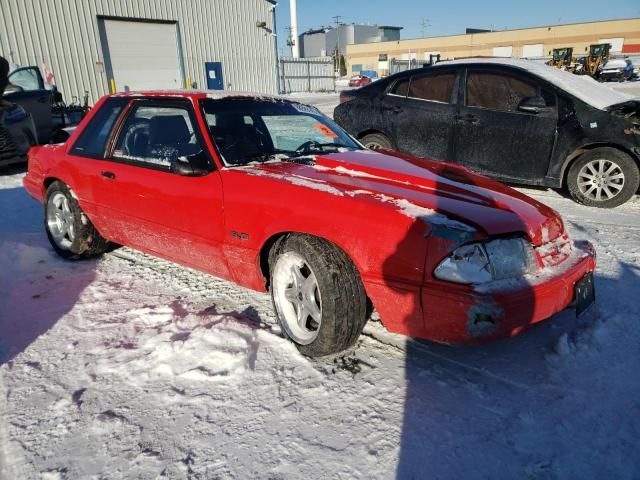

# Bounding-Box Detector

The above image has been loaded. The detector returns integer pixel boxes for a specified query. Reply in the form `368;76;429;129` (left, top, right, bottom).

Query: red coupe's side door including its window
100;100;229;277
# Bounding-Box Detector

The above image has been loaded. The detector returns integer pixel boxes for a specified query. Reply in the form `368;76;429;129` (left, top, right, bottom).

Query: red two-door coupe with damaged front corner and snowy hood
24;91;595;356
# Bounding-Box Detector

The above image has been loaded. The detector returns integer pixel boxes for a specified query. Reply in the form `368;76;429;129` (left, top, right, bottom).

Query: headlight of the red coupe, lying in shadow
433;238;537;283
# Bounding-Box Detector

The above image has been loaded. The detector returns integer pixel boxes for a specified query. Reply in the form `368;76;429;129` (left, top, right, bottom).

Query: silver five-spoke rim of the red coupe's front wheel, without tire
272;252;322;345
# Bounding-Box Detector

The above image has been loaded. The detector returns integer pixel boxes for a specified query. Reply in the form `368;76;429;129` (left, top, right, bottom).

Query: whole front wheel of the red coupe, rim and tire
269;235;367;357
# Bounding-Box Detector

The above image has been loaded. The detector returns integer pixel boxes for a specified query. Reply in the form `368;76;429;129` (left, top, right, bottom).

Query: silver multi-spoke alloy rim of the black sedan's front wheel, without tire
578;159;624;202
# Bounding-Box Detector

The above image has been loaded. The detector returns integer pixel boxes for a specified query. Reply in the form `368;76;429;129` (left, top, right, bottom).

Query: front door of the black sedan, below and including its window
454;68;558;183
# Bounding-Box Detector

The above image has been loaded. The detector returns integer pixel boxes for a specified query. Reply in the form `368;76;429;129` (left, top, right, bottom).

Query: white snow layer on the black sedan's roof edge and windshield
408;57;633;110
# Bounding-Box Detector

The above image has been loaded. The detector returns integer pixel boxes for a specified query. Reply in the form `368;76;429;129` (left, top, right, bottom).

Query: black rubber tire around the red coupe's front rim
269;235;367;357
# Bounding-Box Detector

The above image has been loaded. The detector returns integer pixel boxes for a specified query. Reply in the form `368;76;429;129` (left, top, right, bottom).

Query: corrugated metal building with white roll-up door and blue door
0;0;278;102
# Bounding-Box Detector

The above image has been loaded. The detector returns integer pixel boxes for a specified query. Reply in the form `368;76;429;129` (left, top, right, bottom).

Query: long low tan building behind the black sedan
346;18;640;75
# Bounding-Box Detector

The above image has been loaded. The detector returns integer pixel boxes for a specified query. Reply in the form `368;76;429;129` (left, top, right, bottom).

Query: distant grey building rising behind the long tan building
298;23;402;57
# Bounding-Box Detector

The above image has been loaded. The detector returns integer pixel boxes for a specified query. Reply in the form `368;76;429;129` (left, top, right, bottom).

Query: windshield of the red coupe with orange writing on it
203;98;361;166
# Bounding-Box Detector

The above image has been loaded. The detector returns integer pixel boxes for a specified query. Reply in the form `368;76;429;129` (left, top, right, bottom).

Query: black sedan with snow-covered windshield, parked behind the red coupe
334;59;640;208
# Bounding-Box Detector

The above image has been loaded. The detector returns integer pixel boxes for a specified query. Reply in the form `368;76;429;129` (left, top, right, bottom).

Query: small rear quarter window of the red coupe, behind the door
71;98;129;158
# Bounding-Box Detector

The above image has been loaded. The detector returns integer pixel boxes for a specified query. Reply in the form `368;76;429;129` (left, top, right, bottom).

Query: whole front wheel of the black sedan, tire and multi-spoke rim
567;147;640;208
